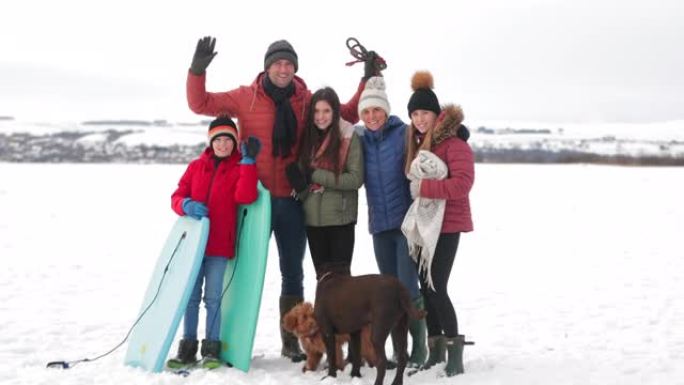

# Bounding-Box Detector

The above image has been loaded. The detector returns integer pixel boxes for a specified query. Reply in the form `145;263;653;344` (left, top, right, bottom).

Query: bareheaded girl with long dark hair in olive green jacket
287;87;363;276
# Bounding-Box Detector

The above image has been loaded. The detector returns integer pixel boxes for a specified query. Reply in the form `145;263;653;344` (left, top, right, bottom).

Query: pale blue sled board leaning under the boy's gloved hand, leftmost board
124;216;209;372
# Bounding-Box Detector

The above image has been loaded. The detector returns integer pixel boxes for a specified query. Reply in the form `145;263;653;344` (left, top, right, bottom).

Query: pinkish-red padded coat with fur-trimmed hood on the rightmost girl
420;105;475;233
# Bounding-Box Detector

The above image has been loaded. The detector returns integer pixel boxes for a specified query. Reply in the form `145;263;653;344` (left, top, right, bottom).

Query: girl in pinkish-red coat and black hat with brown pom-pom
405;72;475;376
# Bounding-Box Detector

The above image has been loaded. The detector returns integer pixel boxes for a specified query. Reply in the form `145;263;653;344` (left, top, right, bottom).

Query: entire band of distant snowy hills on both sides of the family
0;118;684;165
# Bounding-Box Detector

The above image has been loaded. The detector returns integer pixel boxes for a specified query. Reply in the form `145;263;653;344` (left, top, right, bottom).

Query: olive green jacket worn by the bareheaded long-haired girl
303;121;363;227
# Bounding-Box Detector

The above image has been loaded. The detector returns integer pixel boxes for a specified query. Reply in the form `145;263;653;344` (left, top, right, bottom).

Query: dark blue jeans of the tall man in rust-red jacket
271;197;306;297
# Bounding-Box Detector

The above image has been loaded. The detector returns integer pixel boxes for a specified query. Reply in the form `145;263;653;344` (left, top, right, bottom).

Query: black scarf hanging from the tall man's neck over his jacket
264;74;297;158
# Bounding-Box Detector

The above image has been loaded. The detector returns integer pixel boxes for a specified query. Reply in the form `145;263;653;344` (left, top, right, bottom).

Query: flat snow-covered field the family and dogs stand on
0;163;684;385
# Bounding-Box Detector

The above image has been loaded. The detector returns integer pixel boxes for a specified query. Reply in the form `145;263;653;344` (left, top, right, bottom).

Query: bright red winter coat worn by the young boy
171;147;257;259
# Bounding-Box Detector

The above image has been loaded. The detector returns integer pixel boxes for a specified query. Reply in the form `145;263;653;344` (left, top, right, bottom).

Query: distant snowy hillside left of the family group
0;120;208;163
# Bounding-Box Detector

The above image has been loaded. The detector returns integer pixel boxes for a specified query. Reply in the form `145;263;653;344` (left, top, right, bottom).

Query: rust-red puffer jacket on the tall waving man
186;72;364;197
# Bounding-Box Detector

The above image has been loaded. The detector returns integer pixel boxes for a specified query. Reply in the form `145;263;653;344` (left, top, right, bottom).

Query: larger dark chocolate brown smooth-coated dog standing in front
314;264;425;385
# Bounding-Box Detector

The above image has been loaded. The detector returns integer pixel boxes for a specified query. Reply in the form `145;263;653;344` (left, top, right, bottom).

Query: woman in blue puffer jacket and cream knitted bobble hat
357;76;427;367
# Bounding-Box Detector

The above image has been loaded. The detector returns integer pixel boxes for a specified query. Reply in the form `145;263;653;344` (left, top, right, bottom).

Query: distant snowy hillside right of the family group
471;121;684;165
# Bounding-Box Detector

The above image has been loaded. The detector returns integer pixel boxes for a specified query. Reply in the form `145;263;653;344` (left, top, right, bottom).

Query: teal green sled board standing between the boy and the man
221;183;271;372
